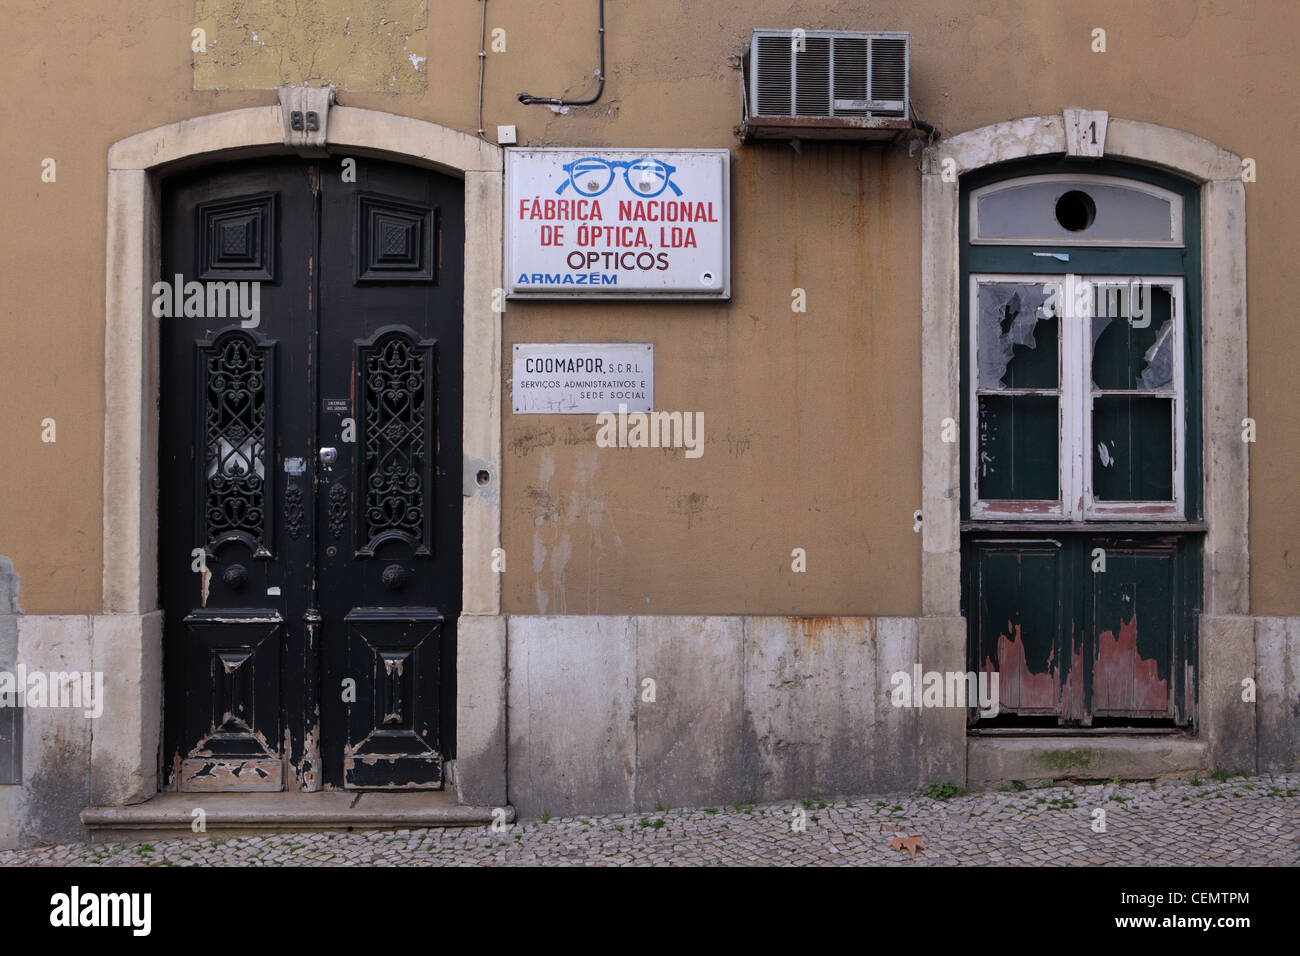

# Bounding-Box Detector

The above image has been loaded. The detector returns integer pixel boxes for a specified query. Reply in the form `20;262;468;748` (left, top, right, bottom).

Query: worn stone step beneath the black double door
81;791;515;843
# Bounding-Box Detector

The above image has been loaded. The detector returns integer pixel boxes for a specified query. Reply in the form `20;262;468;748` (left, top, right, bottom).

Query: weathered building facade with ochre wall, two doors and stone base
0;0;1300;845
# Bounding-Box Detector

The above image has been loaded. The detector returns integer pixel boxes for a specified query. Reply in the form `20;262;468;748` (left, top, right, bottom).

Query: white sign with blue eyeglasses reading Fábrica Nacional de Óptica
506;150;731;299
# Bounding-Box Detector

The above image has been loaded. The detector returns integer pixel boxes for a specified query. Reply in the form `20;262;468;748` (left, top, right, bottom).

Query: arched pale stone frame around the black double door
91;105;506;806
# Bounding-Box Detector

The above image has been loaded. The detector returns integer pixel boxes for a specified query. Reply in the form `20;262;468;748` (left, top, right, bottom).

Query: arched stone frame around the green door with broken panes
920;114;1256;775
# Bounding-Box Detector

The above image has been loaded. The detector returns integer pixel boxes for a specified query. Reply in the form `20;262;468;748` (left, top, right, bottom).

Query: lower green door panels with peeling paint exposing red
963;531;1200;726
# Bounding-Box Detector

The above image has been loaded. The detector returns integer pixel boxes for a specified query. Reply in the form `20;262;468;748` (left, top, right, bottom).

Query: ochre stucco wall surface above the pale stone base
0;0;1300;615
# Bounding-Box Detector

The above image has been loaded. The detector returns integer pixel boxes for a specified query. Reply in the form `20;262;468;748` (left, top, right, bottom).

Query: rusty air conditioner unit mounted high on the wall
741;30;911;139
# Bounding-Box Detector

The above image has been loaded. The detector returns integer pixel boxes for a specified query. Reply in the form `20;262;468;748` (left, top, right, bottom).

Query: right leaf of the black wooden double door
317;160;464;788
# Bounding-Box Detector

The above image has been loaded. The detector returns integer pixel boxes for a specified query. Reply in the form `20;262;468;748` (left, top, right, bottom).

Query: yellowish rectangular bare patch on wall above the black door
192;0;429;92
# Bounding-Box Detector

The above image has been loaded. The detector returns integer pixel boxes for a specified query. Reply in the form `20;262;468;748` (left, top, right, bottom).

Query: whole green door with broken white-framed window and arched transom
961;161;1205;727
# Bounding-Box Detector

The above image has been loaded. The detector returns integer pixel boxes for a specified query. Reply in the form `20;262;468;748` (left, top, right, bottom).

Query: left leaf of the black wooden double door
157;161;316;790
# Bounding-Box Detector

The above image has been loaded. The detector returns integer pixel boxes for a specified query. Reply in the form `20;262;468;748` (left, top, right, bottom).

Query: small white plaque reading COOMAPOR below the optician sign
511;342;654;415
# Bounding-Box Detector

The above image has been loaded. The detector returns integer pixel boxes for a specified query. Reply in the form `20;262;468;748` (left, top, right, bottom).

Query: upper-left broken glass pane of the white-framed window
975;282;1060;389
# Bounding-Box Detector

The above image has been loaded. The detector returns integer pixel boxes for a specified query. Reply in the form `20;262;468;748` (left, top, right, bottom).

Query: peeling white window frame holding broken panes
967;272;1187;522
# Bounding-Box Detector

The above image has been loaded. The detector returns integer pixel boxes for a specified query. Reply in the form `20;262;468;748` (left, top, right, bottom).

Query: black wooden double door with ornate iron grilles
152;157;464;791
